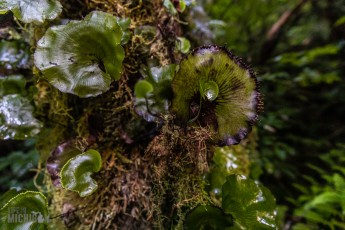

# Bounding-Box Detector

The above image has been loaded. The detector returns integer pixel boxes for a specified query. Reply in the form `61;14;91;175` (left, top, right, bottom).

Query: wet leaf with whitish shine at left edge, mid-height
0;94;41;140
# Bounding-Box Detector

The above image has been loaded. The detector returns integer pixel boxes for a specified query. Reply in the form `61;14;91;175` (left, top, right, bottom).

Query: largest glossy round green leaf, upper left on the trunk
34;11;125;97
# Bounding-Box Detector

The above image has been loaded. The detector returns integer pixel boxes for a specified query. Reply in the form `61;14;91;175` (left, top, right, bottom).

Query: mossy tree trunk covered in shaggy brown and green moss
31;0;253;229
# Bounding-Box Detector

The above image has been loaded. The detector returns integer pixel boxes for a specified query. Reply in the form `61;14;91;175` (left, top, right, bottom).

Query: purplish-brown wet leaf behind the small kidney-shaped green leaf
46;140;82;186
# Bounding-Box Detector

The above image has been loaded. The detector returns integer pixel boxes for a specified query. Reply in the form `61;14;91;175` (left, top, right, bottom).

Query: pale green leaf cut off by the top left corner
0;0;62;24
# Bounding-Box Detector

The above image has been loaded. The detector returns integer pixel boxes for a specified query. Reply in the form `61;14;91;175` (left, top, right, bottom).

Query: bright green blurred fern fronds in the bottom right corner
289;146;345;229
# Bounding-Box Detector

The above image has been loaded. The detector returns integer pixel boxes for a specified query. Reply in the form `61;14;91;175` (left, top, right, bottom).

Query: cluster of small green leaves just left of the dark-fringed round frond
134;64;176;122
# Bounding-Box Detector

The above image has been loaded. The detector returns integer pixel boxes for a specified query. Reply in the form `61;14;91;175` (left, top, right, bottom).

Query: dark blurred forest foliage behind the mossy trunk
0;0;345;229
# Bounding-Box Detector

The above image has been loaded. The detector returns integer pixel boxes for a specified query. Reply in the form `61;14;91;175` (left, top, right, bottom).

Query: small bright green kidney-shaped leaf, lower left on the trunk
60;149;102;197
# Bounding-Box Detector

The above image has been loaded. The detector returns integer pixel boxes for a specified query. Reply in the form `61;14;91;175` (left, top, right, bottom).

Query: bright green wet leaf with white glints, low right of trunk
222;175;277;230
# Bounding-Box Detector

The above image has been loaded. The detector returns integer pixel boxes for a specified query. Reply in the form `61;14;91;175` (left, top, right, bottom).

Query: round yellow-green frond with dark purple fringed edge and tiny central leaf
172;45;263;145
